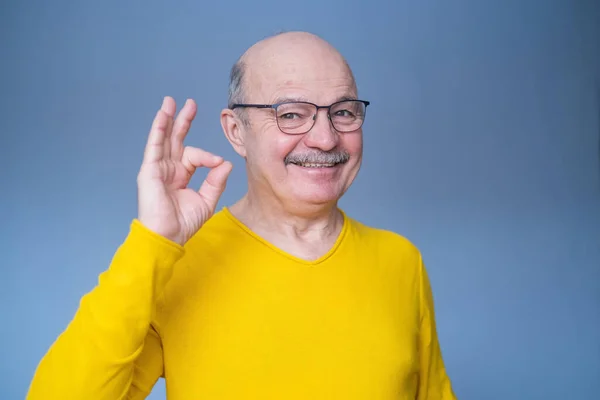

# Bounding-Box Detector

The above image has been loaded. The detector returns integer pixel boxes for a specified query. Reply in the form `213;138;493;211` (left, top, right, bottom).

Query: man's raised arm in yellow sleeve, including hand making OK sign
27;96;233;400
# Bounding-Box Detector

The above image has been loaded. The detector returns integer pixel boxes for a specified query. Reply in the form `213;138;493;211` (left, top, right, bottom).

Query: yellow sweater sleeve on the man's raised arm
27;220;184;400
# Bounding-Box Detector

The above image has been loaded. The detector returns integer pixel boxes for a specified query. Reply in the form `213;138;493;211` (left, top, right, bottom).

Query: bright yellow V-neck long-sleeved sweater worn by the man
28;208;455;400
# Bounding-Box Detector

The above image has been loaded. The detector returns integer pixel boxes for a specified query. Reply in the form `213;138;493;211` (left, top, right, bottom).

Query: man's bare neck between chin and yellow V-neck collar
229;191;343;242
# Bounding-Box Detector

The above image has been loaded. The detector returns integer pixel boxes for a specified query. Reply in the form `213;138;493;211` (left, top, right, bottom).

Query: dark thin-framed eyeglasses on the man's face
230;100;370;135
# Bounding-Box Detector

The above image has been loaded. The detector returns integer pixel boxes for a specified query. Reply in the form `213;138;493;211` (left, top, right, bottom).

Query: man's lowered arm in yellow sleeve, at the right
417;261;456;400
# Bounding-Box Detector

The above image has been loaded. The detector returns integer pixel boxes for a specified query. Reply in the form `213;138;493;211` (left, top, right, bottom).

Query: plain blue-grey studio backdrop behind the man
0;0;600;400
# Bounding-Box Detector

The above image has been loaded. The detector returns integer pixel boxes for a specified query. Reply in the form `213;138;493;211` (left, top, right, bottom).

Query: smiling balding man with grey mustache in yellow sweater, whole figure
28;32;455;400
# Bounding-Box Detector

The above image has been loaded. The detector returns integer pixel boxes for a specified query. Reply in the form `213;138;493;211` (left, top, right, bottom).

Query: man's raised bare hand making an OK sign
137;97;233;245
